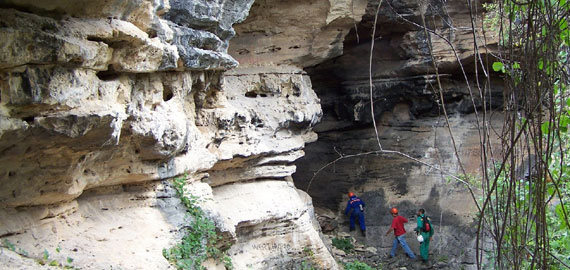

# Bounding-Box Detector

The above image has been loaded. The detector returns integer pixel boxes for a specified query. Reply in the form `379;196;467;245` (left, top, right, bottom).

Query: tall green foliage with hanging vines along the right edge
480;0;570;269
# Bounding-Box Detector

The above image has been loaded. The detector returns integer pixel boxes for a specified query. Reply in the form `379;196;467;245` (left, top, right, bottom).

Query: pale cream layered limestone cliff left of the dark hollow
0;0;366;269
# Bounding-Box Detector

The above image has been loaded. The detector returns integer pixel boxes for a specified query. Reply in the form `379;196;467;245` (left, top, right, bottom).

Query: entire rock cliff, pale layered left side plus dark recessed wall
0;0;501;269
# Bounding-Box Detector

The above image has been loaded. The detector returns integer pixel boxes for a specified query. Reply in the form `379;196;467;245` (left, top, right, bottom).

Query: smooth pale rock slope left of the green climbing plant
1;182;182;269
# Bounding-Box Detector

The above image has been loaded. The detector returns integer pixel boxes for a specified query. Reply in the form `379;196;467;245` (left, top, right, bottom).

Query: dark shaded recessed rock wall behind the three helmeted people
293;1;502;269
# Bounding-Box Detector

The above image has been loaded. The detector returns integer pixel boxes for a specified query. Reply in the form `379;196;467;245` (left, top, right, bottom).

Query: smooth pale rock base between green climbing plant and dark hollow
197;178;337;269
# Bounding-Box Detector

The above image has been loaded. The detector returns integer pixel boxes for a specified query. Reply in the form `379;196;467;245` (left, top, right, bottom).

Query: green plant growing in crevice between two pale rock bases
162;175;233;270
